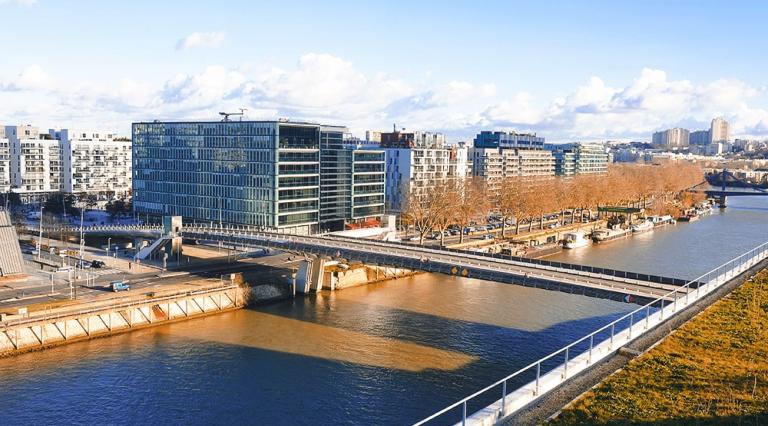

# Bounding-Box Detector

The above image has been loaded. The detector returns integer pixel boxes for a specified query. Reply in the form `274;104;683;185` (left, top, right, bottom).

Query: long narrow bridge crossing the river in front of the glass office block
36;224;697;304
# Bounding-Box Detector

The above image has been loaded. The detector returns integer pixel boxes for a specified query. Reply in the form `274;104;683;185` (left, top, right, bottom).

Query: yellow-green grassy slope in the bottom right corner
553;270;768;425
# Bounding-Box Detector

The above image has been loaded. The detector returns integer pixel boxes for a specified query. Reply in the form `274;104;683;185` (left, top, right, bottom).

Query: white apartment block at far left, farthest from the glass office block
5;125;62;194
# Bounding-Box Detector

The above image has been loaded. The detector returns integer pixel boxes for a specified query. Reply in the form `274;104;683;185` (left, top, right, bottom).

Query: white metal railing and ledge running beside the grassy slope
415;242;768;426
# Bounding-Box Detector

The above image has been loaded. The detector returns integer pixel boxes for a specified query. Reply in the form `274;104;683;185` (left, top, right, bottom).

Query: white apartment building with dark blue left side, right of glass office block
384;146;469;212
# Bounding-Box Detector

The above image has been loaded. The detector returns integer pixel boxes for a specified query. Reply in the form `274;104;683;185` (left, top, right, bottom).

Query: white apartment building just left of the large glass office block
49;129;132;194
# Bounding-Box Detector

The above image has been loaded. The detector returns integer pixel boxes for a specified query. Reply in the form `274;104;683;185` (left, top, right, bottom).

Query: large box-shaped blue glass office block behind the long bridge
133;121;383;234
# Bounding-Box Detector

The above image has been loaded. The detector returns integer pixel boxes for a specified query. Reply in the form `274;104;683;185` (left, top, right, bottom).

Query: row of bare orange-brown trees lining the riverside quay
401;163;703;244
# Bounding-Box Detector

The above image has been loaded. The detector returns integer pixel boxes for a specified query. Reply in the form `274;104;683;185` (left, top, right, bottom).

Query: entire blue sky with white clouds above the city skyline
0;0;768;141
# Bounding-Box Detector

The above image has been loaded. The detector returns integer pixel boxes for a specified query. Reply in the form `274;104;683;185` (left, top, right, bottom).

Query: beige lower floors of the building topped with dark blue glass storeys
469;148;555;182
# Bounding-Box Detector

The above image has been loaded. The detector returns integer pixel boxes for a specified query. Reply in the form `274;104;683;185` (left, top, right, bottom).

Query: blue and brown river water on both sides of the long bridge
0;197;768;425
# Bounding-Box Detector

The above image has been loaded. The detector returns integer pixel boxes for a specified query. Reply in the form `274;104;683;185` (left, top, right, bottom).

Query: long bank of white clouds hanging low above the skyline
0;53;768;141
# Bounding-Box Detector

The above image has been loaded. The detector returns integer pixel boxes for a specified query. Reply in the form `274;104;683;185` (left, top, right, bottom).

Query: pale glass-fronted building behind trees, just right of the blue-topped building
546;142;608;176
